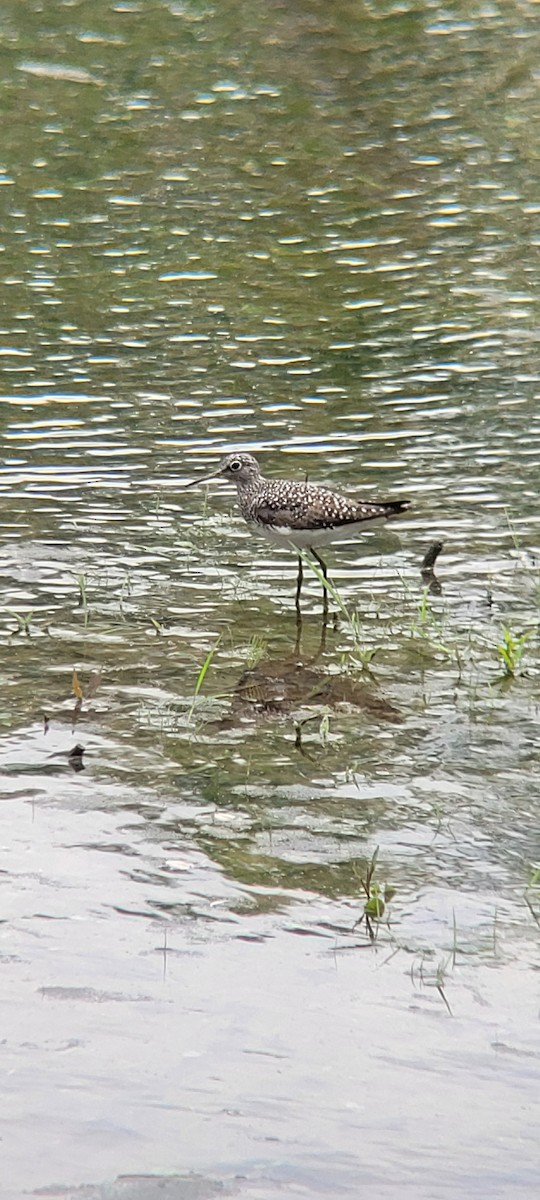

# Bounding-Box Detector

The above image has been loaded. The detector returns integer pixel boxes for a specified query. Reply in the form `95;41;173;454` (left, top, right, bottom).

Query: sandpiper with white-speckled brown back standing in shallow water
185;454;410;607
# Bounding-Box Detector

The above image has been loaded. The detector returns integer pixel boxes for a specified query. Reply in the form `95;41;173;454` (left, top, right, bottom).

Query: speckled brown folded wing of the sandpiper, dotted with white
245;480;409;529
